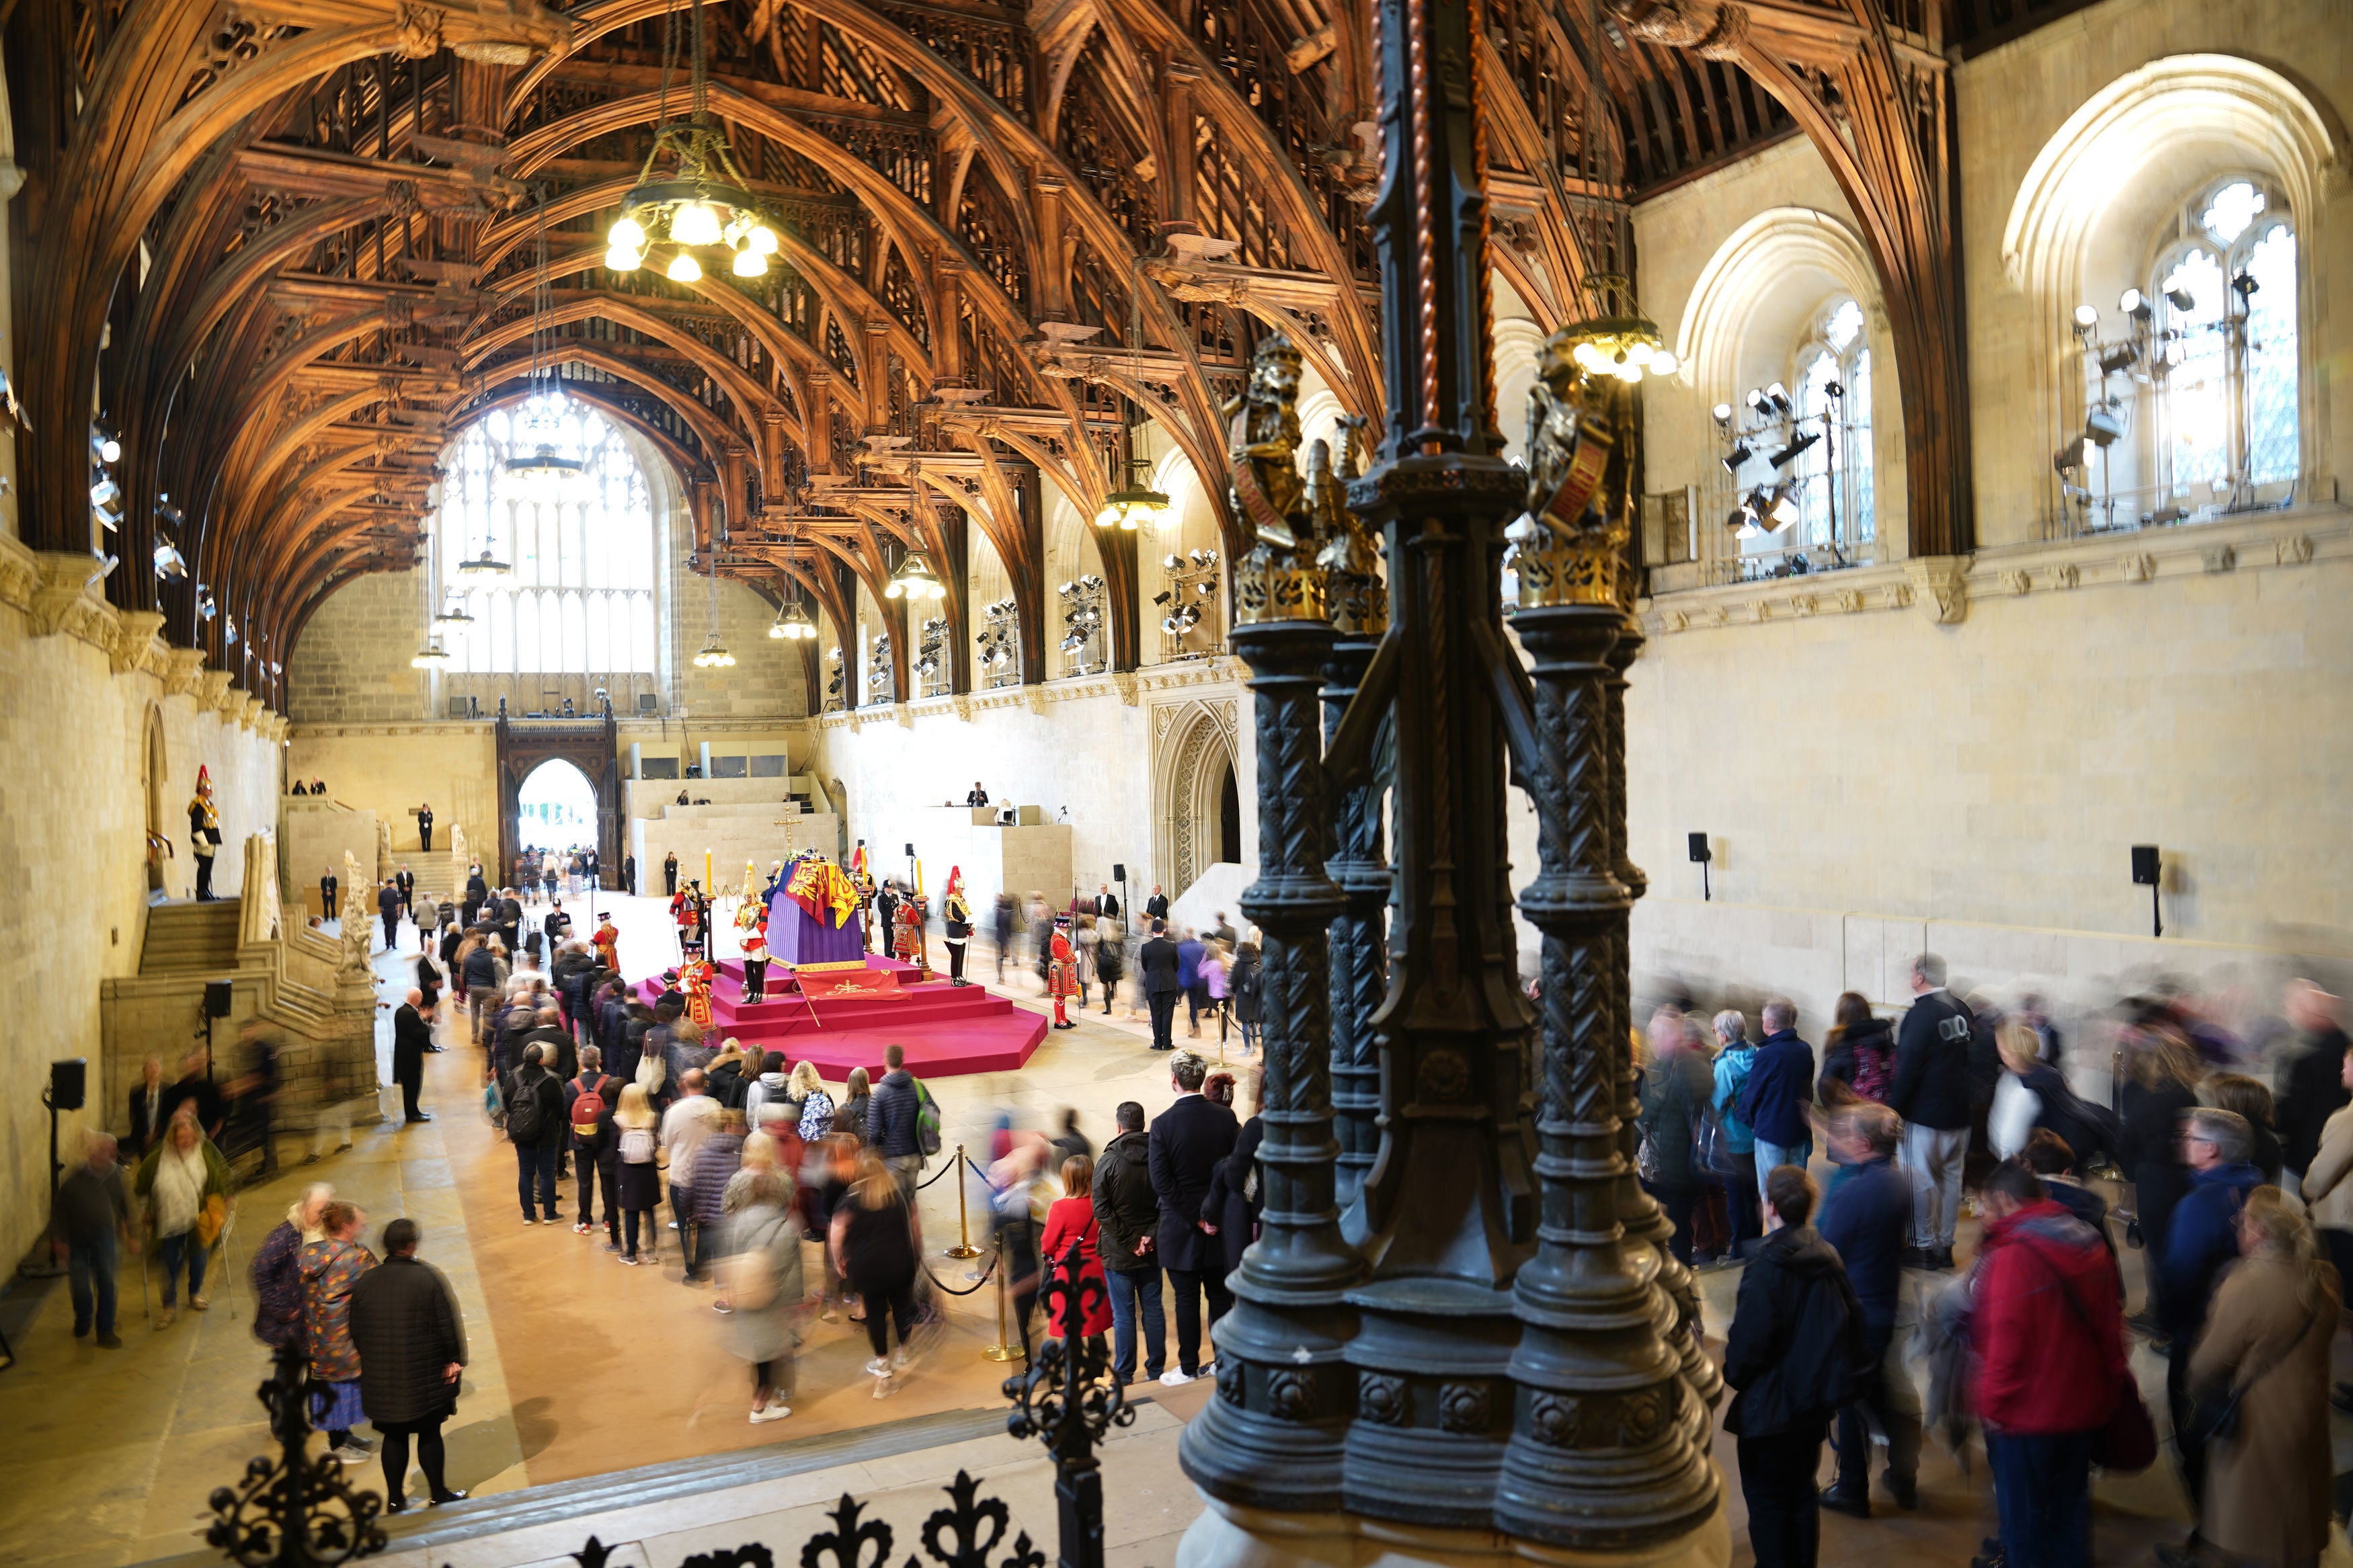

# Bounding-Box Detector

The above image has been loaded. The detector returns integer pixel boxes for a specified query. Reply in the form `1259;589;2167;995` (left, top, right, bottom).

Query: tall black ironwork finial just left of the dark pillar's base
1005;1241;1137;1568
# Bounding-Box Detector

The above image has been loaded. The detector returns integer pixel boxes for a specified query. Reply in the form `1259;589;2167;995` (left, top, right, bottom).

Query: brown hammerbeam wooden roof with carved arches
0;0;2078;703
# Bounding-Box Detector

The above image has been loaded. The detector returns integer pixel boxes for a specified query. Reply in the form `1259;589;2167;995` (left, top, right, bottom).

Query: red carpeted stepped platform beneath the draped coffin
638;957;1047;1083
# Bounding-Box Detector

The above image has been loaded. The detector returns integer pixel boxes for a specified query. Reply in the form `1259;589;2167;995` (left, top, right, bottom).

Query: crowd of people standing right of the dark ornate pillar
1640;954;2353;1568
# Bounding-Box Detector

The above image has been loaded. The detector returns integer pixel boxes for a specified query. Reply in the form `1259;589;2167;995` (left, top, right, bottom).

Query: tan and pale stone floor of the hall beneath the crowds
0;898;2344;1568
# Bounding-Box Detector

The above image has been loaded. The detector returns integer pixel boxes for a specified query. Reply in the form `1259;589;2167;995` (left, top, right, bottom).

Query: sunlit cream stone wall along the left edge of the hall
0;540;282;1262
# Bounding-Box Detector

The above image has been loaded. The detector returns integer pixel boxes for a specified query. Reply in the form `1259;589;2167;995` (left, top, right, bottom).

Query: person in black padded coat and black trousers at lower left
351;1218;466;1514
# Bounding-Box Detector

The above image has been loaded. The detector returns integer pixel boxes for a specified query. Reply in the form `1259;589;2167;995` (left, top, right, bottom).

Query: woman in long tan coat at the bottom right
2160;1187;2344;1568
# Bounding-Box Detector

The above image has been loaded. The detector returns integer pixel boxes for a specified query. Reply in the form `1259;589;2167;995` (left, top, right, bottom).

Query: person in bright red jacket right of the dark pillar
1970;1159;2139;1568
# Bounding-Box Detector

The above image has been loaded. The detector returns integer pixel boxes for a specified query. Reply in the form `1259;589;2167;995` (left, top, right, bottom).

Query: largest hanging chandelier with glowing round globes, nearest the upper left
605;0;776;282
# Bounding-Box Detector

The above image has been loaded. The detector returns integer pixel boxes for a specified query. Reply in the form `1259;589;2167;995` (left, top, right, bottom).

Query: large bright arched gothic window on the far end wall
436;397;662;675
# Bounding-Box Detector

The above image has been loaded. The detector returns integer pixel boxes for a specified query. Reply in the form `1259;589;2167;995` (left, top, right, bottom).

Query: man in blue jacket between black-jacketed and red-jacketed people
1817;1100;1920;1519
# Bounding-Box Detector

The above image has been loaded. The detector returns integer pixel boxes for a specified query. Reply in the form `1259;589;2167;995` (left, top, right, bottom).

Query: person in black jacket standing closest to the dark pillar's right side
1725;1166;1868;1568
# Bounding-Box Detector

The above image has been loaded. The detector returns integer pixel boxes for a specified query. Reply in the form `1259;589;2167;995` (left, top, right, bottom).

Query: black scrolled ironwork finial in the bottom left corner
205;1345;384;1568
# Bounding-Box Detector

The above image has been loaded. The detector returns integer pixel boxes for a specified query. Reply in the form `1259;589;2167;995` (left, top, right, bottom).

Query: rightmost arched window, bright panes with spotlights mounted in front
2057;174;2301;529
